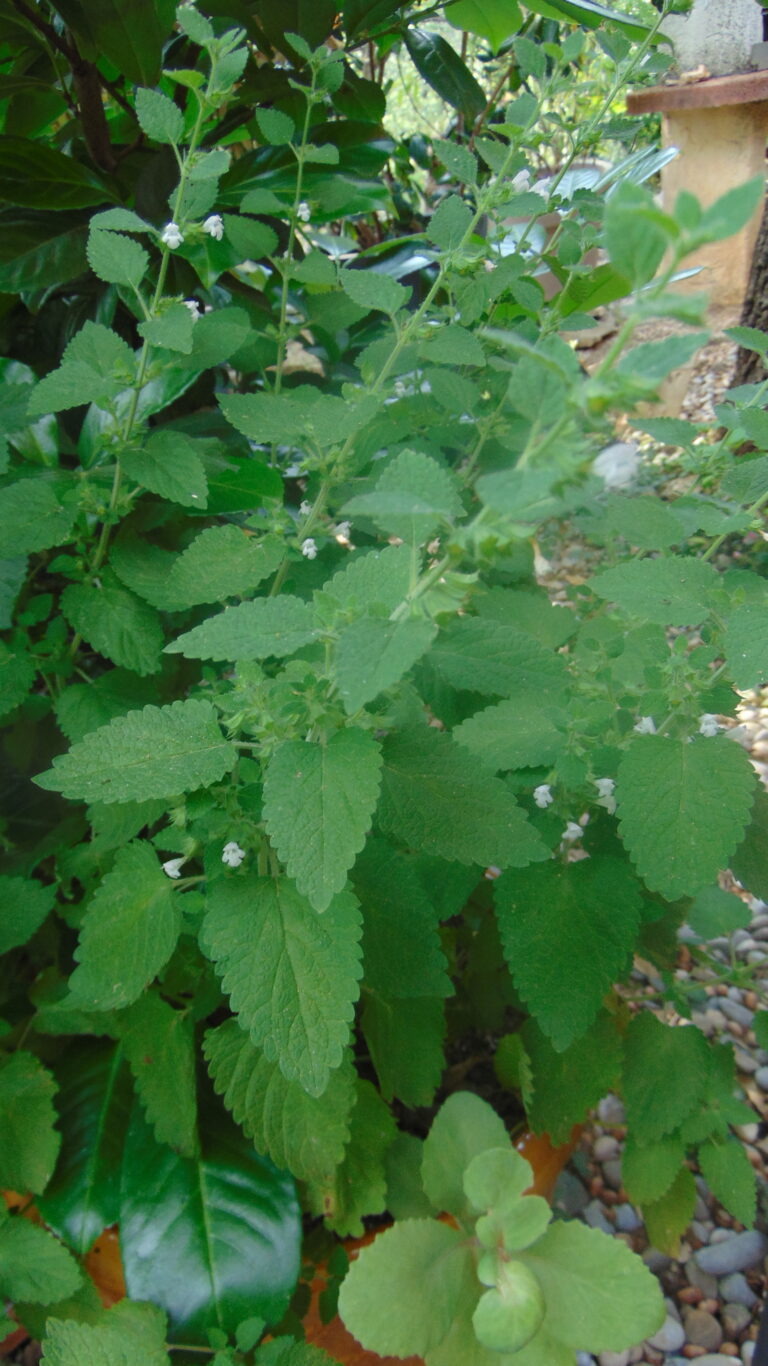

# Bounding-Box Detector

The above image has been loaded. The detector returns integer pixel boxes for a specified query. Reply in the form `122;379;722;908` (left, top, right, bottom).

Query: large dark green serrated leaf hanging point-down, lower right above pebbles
493;858;642;1052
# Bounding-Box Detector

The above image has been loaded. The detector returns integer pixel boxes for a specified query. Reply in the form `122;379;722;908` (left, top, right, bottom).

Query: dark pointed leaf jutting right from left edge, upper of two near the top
0;138;115;209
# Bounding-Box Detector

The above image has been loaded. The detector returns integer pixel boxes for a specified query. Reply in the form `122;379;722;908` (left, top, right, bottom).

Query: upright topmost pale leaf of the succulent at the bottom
421;1091;511;1218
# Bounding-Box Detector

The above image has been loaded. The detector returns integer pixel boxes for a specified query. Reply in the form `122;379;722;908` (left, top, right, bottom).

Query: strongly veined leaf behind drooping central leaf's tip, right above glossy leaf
204;1020;354;1182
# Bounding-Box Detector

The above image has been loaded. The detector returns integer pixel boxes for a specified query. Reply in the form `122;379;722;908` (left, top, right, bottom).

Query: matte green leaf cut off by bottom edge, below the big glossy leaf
42;1299;171;1366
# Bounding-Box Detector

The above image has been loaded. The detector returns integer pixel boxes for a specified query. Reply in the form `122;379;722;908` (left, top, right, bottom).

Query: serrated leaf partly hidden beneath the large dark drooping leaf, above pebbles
512;1011;622;1143
